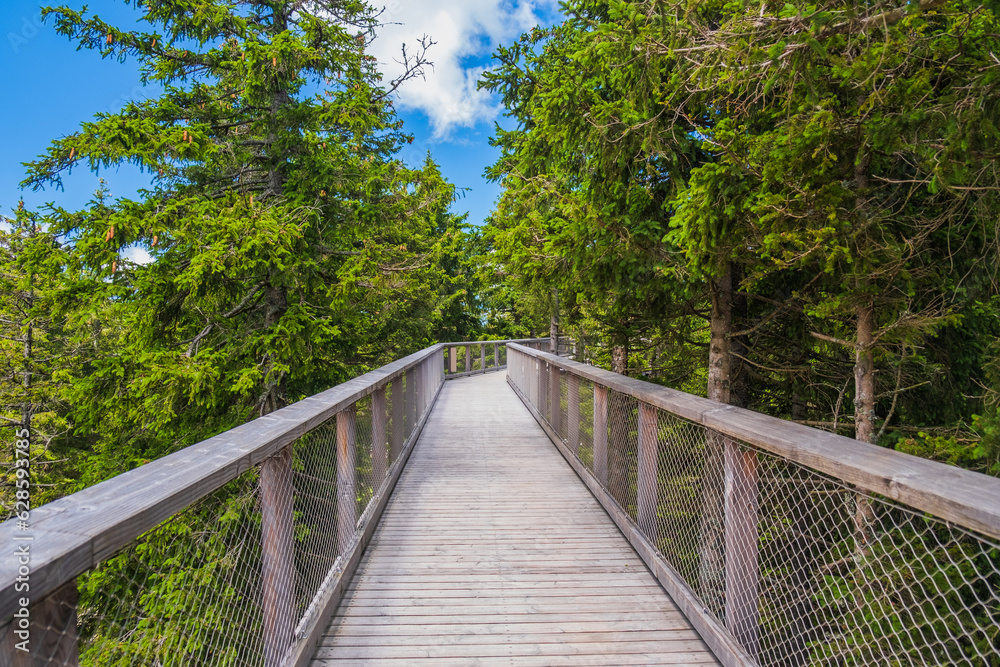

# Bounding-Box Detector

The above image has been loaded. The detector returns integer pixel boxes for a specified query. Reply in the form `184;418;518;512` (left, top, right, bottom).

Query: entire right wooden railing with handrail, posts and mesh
507;345;1000;665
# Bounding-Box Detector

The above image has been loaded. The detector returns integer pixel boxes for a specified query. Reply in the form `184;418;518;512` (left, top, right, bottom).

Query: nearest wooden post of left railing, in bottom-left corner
0;580;80;667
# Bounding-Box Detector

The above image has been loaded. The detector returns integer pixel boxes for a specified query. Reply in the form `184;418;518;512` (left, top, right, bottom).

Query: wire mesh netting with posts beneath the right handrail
508;353;1000;666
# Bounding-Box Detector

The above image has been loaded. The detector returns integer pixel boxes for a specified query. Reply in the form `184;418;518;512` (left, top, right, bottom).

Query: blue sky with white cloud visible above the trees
0;0;557;230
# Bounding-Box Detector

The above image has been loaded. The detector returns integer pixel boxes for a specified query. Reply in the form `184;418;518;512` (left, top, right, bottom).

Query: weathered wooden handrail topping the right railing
508;343;1000;539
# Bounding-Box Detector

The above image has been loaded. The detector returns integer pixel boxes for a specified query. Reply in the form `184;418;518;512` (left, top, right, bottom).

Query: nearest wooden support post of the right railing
724;438;760;658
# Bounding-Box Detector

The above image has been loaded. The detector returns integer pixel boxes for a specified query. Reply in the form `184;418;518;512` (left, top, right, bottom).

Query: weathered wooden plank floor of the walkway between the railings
312;372;718;667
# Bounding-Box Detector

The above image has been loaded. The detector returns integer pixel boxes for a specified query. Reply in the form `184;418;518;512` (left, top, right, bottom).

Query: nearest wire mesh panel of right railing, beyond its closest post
752;445;1000;665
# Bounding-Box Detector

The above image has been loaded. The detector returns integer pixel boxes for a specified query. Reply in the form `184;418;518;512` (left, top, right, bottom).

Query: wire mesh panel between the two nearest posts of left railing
76;470;264;667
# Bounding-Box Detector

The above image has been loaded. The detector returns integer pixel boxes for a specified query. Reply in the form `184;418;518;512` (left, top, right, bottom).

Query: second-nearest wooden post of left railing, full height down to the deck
260;444;294;667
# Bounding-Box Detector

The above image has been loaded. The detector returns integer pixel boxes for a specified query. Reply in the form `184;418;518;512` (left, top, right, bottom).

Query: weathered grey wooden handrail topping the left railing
0;345;443;622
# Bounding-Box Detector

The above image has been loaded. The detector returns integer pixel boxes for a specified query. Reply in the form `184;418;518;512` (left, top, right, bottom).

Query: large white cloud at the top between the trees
370;0;556;139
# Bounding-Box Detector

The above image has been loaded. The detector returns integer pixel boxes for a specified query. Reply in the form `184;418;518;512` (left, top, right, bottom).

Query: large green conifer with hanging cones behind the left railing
24;0;458;465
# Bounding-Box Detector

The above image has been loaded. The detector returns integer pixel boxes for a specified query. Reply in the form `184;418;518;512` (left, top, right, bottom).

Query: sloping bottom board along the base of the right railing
510;374;755;667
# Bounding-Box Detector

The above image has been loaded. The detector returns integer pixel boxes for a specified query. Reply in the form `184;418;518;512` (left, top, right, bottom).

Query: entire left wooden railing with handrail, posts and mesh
0;339;547;667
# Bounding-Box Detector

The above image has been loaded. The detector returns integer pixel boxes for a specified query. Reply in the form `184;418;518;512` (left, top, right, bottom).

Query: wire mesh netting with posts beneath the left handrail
48;355;443;667
